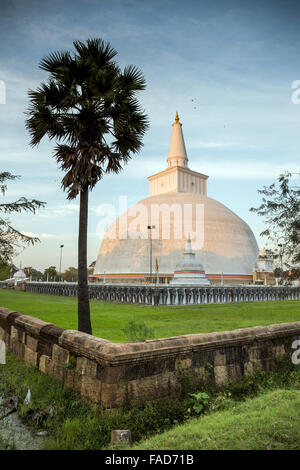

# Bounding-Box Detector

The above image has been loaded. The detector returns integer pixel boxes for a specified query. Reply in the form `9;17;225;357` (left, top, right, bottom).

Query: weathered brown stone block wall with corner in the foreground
0;308;300;408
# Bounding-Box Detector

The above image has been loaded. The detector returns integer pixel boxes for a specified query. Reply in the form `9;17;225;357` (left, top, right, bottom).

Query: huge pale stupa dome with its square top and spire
93;115;258;284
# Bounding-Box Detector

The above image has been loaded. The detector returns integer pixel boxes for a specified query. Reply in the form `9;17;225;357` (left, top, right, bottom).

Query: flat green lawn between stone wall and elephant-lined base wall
0;289;300;342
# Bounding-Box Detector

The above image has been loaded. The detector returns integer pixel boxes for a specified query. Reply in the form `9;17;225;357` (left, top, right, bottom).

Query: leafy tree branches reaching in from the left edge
0;172;45;263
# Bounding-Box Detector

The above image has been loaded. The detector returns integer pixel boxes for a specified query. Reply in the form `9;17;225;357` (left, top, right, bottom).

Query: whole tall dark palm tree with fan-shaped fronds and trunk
26;39;148;333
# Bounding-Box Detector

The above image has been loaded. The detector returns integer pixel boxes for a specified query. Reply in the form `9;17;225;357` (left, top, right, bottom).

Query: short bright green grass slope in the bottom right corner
133;390;300;450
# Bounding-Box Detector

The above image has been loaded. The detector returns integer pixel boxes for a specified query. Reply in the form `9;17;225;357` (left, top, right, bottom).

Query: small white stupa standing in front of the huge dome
170;236;210;287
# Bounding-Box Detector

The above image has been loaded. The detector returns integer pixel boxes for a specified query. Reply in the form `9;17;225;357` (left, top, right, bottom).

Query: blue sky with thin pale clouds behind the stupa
0;0;300;270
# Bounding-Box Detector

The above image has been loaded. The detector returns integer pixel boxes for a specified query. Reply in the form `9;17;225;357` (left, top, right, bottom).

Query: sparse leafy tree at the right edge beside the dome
250;172;300;279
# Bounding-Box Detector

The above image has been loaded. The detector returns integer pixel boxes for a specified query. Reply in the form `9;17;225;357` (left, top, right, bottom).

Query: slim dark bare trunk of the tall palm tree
78;189;92;334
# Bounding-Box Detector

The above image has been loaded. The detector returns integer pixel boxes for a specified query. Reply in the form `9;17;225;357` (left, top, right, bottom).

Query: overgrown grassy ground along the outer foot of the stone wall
0;354;300;449
